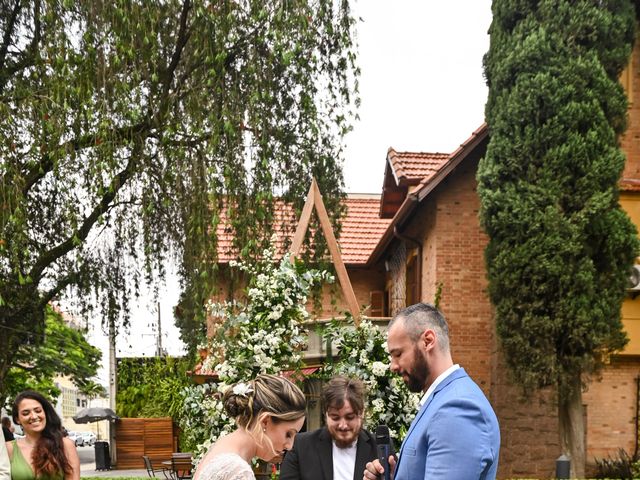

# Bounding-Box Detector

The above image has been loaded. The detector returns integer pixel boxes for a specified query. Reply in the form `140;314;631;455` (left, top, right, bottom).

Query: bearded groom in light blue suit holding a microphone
364;303;500;480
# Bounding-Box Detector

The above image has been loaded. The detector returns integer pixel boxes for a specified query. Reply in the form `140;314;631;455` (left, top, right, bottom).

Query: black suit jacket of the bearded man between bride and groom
280;428;378;480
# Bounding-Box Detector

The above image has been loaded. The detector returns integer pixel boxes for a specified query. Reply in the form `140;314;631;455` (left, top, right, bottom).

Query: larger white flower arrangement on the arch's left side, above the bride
181;249;333;457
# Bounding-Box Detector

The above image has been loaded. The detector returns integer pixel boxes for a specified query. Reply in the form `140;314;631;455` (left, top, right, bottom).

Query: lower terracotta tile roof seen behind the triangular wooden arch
216;194;391;265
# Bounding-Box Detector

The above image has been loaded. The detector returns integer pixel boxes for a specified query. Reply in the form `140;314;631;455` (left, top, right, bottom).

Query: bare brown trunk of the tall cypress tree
558;375;586;478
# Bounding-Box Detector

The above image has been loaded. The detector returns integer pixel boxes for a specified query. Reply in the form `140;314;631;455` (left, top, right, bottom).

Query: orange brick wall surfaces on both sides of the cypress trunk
409;152;640;478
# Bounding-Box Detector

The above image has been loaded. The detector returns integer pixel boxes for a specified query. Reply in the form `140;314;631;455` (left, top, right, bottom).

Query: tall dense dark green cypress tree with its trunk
478;0;638;477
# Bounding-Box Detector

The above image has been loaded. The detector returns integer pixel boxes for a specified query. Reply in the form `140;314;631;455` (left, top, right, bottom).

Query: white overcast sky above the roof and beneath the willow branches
90;0;491;381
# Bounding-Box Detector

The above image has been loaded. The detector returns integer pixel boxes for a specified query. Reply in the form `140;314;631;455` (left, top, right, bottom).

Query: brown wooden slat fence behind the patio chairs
116;417;178;469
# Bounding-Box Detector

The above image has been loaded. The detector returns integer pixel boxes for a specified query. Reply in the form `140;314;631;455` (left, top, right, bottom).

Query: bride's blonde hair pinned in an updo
222;374;306;454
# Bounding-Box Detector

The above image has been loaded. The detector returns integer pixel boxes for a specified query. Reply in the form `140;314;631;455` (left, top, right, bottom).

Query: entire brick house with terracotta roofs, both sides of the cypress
199;31;640;478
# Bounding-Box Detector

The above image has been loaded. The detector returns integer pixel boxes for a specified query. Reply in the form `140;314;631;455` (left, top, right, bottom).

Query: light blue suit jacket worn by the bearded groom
394;368;500;480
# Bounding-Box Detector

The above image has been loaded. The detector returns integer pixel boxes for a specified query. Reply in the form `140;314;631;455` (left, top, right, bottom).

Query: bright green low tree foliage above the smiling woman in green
0;306;102;406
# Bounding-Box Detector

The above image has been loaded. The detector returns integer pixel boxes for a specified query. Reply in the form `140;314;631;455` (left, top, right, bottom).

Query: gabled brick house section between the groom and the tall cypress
369;125;560;478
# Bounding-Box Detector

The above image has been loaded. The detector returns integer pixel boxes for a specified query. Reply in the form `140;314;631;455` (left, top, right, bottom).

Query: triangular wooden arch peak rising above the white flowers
289;178;360;327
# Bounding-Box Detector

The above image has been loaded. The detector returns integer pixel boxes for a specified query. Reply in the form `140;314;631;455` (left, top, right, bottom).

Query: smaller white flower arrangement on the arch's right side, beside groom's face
322;318;420;445
